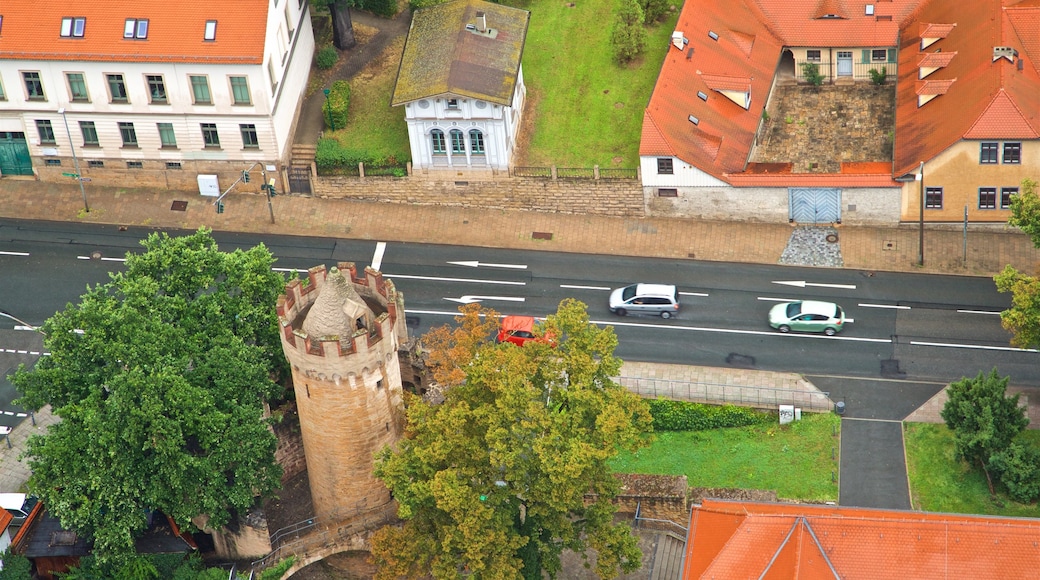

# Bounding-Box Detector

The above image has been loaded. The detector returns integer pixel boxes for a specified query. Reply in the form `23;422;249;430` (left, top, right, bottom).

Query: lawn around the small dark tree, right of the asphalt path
904;423;1040;518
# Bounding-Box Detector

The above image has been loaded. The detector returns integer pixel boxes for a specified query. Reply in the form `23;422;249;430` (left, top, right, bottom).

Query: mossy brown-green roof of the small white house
390;0;530;106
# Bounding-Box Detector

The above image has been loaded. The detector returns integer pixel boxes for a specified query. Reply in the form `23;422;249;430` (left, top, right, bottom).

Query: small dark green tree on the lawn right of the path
941;369;1030;494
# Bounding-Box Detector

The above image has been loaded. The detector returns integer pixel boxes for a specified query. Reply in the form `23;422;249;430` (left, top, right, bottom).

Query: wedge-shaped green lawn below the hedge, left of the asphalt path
613;413;841;501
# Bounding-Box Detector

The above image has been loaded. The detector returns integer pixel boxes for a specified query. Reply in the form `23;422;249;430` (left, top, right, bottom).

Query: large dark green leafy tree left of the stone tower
12;230;284;570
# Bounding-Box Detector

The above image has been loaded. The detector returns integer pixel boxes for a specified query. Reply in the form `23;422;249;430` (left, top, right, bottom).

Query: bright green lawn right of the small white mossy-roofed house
506;0;681;167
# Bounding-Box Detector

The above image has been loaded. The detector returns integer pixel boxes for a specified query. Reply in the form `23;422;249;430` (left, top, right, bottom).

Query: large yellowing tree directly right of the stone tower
372;300;651;579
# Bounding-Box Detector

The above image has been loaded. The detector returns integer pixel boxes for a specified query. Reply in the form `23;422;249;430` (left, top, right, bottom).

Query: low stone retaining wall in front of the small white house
312;177;643;216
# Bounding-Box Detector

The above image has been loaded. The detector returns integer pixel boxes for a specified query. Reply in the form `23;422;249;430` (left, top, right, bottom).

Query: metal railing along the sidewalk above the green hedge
618;376;834;413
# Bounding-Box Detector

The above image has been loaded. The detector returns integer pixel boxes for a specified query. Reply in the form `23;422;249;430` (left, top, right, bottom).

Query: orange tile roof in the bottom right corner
682;500;1040;580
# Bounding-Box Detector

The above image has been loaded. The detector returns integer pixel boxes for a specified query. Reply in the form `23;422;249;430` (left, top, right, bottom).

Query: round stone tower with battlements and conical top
278;263;408;517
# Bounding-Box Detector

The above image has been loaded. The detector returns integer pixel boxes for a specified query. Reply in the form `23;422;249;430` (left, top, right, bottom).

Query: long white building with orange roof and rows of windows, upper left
0;0;314;189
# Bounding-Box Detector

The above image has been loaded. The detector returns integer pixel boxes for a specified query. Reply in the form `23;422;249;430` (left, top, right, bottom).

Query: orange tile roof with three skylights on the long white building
0;0;270;64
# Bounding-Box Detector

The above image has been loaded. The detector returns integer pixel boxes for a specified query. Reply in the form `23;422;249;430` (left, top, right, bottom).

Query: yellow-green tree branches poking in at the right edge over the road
993;179;1040;348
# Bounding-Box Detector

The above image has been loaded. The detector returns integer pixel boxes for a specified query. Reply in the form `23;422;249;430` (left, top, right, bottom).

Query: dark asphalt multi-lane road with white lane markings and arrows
0;220;1040;430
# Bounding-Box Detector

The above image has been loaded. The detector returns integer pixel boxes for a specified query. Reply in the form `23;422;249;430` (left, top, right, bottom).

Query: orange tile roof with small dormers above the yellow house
893;0;1040;175
